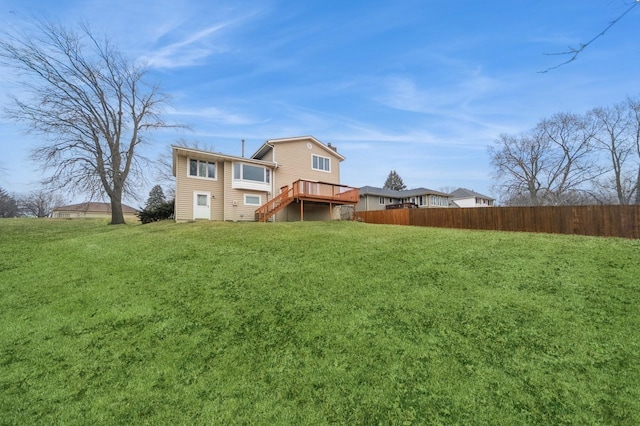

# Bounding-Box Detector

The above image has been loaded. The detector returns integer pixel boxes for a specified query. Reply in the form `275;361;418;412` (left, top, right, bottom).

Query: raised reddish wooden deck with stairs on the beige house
256;179;360;222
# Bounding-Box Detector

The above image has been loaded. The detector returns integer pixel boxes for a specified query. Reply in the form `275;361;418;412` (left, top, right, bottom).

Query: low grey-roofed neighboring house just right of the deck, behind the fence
356;186;451;211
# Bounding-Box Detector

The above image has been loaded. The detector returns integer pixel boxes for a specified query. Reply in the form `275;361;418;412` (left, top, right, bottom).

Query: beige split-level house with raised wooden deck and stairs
172;136;358;221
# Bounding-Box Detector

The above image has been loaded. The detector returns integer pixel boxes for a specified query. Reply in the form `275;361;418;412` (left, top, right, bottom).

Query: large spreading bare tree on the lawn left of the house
0;21;175;224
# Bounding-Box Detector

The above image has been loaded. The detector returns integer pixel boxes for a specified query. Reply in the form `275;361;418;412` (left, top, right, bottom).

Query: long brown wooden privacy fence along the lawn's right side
356;205;640;238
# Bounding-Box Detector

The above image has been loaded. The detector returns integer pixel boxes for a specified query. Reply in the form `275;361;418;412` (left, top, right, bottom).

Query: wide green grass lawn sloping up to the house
0;219;640;425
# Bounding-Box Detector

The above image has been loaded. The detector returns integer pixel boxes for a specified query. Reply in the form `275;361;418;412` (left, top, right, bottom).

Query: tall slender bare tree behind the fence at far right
589;103;635;204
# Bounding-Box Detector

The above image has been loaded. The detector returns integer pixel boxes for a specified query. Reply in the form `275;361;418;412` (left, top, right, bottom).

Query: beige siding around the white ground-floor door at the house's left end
175;155;226;221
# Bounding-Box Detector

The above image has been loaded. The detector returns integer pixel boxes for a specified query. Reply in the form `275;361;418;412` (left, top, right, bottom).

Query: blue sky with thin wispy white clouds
0;0;640;204
